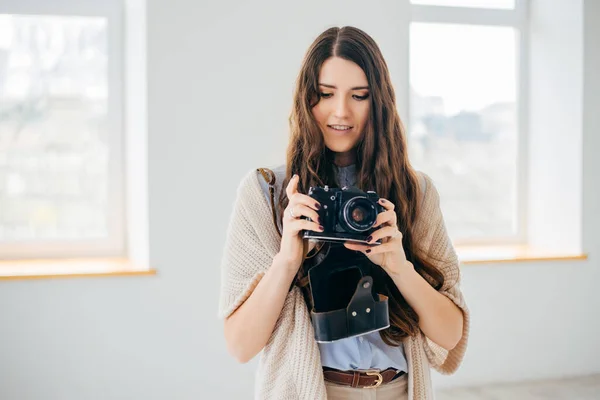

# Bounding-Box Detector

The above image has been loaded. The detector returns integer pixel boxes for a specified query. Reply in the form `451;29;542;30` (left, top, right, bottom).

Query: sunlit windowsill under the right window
456;245;587;265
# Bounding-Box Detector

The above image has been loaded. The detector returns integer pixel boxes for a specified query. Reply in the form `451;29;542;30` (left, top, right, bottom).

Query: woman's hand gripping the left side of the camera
279;175;323;271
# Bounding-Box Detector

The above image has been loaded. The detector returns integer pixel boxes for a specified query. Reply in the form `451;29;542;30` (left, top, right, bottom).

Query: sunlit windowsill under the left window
0;258;156;280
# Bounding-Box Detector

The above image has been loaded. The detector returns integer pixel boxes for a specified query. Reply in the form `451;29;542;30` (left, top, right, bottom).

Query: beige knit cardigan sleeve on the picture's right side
416;174;470;374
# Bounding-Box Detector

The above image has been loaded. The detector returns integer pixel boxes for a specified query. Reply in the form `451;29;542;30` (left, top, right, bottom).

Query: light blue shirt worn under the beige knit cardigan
259;165;408;372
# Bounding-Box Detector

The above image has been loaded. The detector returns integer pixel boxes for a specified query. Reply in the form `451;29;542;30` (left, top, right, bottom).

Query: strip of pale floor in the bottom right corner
436;375;600;400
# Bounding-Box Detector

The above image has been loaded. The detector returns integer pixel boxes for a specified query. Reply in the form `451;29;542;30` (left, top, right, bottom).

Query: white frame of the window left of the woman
0;0;127;259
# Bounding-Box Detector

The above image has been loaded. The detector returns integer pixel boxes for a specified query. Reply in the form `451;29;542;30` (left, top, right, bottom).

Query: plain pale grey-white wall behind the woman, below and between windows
0;0;600;400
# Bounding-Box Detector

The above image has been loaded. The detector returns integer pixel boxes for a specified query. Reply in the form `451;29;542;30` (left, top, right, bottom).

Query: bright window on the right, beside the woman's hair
408;0;524;244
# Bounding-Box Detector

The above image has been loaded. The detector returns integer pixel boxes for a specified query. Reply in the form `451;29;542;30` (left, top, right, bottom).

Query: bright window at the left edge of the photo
0;1;125;258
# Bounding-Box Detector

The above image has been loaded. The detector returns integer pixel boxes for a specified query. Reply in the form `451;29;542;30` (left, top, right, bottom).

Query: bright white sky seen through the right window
410;22;517;114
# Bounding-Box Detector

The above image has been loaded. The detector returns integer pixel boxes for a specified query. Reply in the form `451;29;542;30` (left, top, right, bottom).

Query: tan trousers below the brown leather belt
325;374;408;400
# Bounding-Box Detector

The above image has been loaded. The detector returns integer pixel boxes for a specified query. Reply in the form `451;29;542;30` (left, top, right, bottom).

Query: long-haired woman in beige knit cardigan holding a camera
220;27;469;400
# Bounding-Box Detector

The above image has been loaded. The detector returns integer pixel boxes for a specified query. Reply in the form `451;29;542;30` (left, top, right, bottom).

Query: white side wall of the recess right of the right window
527;0;584;254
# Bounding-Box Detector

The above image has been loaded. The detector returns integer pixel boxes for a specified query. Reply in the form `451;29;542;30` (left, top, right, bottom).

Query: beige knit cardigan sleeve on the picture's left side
218;170;280;319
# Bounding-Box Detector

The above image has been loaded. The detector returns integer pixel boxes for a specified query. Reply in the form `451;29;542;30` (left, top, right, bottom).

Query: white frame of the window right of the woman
406;0;529;246
